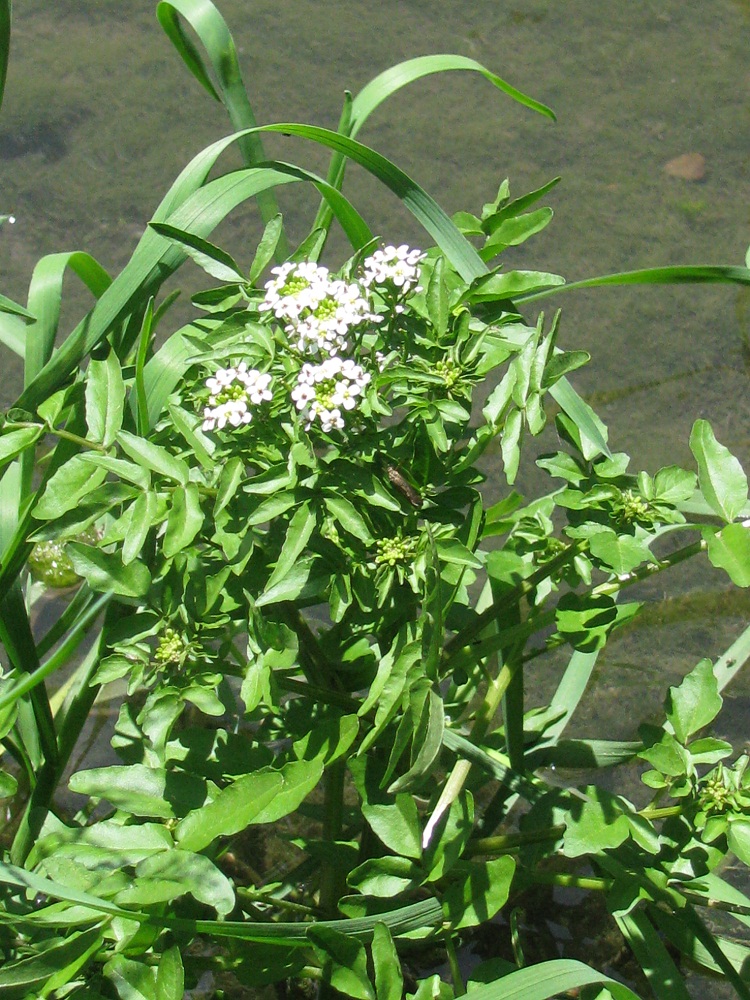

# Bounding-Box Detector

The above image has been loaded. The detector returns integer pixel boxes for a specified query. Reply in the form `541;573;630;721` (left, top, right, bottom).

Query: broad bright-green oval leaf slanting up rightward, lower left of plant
174;771;284;851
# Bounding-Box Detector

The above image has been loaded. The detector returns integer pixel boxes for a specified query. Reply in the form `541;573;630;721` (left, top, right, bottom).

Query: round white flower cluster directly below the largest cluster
292;358;371;432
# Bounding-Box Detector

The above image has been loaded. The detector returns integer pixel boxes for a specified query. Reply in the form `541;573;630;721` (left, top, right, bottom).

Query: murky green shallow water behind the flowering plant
0;0;750;992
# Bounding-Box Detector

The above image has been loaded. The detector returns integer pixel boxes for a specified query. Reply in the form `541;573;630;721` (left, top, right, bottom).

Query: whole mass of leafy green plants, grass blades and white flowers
0;0;750;1000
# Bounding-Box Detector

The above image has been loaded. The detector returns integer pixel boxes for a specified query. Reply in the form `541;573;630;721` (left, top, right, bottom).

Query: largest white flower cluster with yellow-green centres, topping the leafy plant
259;262;379;357
